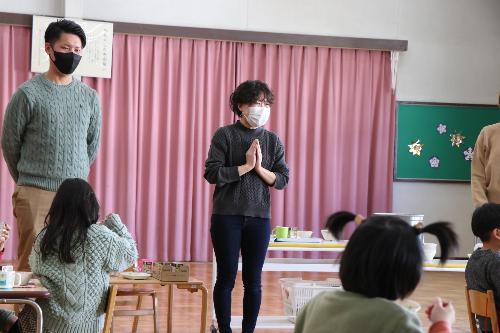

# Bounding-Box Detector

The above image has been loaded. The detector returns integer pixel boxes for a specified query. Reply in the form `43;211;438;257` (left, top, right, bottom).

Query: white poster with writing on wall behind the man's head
31;16;113;78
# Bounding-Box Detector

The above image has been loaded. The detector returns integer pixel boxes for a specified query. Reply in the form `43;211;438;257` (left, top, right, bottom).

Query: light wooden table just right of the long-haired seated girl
109;276;208;333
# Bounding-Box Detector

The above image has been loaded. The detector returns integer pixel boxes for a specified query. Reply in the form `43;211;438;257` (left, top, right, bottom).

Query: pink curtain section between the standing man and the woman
84;35;235;260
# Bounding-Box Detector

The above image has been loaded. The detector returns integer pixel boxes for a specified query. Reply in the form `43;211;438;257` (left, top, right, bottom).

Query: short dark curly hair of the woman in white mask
229;80;274;117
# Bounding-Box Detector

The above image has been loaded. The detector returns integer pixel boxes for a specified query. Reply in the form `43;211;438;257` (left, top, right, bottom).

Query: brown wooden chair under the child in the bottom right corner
465;286;500;333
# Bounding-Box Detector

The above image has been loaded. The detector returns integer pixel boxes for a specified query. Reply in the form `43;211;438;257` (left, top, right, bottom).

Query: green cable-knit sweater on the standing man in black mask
2;74;101;192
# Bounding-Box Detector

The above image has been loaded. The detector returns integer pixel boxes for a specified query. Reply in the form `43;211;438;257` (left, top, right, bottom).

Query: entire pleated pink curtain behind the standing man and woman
0;25;394;261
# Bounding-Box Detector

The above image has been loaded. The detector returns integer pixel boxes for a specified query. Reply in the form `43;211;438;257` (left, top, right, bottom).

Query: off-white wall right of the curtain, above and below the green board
393;0;500;256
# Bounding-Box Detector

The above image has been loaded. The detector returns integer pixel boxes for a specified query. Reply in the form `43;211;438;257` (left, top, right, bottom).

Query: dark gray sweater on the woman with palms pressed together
205;121;289;218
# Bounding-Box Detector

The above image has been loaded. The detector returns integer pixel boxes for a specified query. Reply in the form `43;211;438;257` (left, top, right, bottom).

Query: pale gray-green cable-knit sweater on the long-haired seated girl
29;214;137;333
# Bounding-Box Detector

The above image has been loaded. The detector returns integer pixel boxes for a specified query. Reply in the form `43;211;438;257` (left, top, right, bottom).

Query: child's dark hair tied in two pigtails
327;211;457;300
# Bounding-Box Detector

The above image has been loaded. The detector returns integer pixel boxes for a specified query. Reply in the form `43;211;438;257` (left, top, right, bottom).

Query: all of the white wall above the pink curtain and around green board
0;0;500;255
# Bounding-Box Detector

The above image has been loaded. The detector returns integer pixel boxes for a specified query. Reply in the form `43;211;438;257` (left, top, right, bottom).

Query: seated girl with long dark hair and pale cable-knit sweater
15;178;137;333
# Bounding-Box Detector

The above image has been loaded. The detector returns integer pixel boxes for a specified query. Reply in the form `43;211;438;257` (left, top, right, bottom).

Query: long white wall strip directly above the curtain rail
84;0;398;37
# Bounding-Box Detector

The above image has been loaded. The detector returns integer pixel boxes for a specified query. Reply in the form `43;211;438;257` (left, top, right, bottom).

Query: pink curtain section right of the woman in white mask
237;43;395;239
